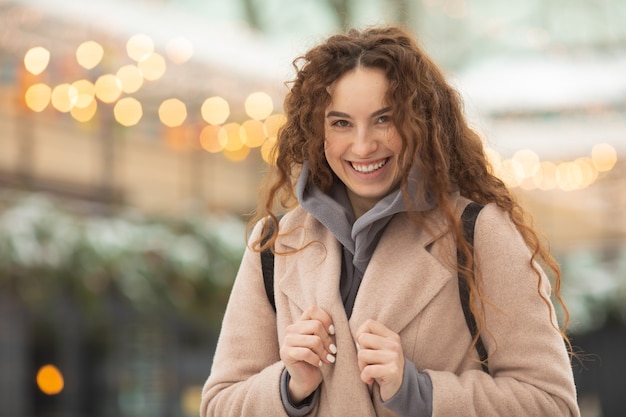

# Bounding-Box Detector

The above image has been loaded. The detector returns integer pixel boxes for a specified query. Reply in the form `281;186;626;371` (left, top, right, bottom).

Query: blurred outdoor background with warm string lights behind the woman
0;0;626;417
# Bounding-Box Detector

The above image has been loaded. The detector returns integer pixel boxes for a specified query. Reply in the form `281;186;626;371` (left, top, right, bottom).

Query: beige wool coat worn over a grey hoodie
201;197;579;417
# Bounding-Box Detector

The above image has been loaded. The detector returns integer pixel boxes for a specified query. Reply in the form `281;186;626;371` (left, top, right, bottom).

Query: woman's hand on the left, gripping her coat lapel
280;306;337;404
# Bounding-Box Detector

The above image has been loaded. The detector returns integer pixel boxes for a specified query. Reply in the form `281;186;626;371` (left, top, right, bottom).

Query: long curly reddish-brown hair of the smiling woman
250;27;571;358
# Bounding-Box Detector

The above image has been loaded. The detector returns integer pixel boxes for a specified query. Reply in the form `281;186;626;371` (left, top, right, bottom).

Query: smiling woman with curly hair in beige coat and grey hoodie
201;27;579;417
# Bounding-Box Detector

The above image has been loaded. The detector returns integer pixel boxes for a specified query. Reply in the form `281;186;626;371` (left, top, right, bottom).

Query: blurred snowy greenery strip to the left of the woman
0;192;245;329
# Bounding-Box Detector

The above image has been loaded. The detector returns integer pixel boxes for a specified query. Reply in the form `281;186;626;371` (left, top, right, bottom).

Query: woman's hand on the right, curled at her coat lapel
356;320;404;401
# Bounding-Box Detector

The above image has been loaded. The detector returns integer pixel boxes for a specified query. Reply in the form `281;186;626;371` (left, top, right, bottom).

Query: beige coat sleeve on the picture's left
200;219;287;417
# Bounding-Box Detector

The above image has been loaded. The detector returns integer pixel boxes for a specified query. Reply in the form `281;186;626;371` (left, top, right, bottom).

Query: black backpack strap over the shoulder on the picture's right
457;202;489;372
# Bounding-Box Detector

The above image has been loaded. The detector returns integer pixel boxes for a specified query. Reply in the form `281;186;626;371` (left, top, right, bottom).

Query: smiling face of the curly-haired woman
324;67;402;218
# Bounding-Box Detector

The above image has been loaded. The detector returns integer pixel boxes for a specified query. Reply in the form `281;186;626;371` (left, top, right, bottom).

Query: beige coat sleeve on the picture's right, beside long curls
428;204;580;417
